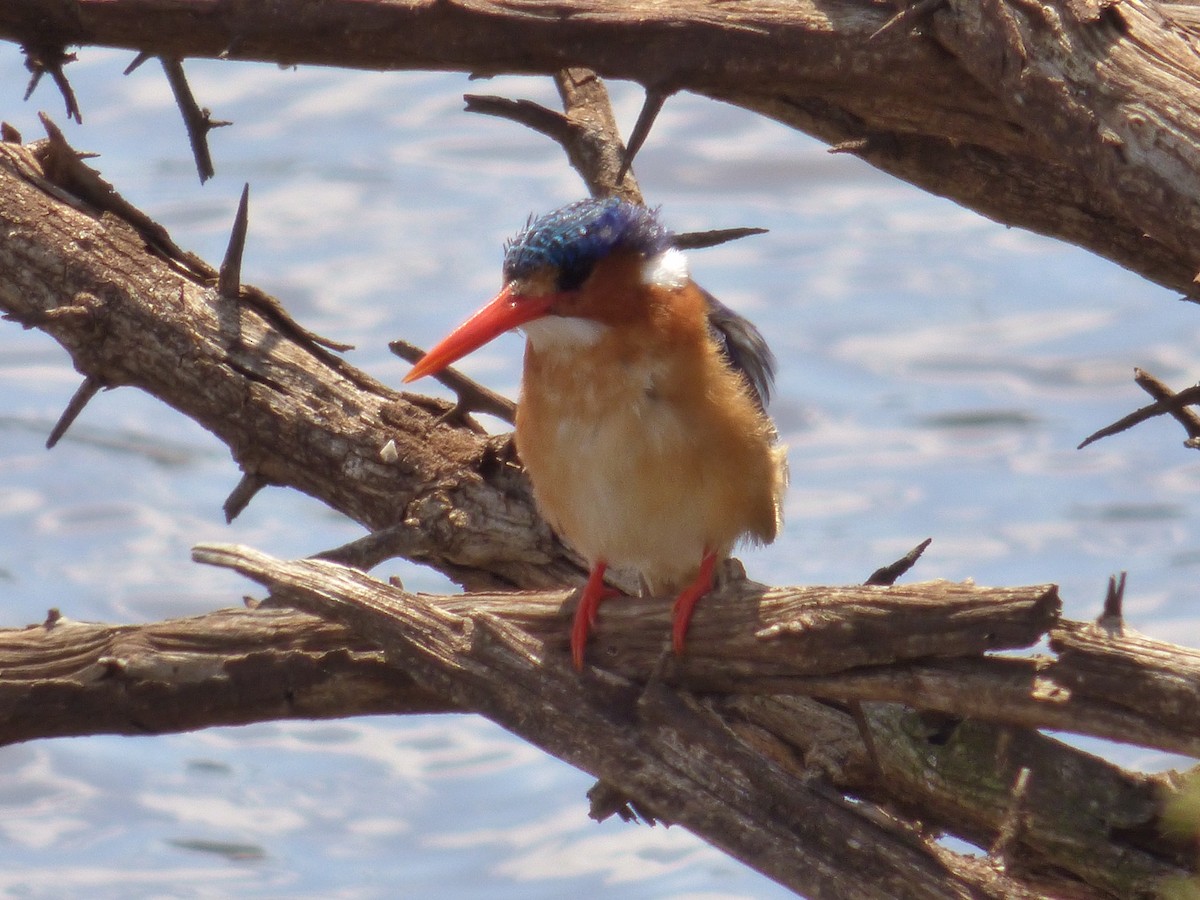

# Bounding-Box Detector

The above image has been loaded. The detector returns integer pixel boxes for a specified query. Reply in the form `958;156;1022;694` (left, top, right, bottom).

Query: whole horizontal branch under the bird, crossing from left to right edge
0;582;1200;756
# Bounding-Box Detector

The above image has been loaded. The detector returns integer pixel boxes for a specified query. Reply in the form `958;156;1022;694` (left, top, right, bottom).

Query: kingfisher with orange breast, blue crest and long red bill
404;197;786;670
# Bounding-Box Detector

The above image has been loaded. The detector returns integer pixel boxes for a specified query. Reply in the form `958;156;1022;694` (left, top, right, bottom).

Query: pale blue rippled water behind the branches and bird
0;44;1200;898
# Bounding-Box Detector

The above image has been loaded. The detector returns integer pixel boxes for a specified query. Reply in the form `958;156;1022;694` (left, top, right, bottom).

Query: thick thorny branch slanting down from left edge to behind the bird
0;132;577;588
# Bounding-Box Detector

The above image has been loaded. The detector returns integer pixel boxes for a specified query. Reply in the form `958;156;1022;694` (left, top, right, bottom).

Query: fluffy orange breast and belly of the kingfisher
516;286;784;593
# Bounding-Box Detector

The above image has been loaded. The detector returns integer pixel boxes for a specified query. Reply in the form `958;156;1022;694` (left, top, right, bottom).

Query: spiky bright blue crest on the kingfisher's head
504;197;673;290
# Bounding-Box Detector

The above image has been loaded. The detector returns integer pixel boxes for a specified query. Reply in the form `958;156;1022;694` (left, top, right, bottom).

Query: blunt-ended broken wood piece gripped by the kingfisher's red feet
438;581;1060;676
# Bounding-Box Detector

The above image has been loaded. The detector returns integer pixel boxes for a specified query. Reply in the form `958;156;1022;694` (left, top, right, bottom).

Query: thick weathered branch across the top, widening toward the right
0;0;1200;296
